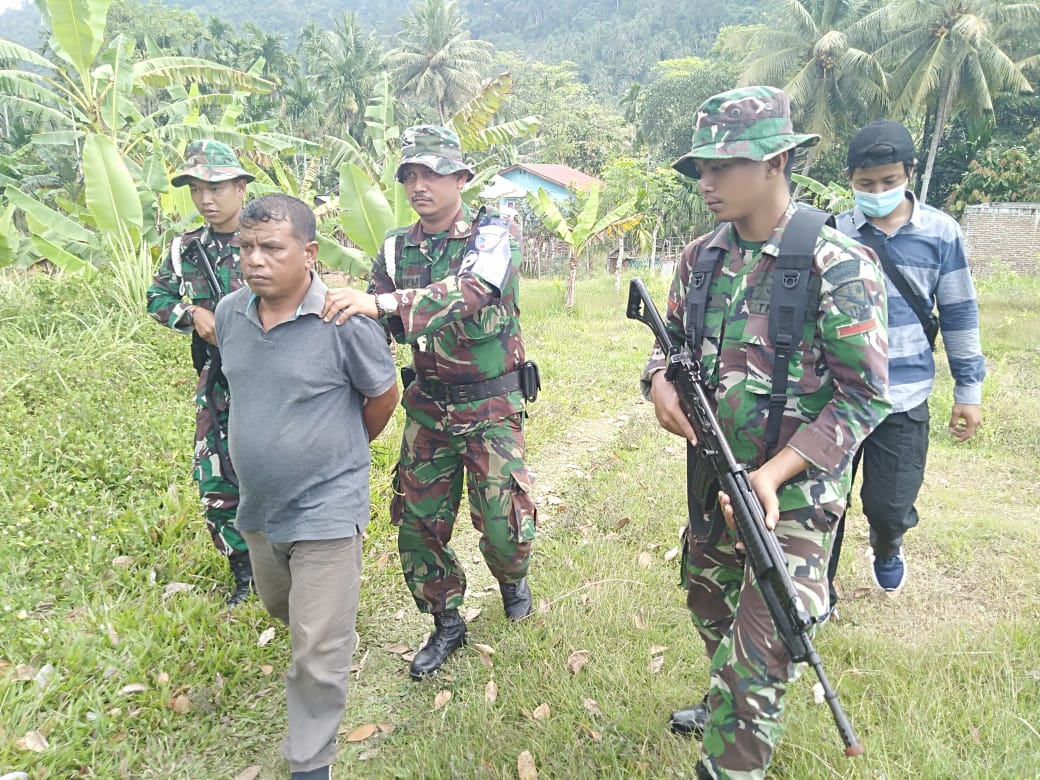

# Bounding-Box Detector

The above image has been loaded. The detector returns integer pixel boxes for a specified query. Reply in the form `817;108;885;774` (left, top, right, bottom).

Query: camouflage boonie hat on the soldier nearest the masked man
672;86;820;179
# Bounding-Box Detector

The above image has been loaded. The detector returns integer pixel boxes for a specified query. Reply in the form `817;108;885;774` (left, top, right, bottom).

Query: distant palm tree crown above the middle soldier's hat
387;0;492;125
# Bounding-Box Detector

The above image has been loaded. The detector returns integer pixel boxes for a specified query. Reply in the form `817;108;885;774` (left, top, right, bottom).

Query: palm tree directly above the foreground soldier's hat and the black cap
728;0;888;175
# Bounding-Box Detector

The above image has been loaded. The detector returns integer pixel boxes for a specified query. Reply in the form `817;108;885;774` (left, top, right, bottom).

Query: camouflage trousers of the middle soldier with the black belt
390;415;538;613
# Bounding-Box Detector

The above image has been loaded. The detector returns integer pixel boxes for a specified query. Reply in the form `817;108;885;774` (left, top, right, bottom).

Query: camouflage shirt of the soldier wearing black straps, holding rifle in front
643;203;891;511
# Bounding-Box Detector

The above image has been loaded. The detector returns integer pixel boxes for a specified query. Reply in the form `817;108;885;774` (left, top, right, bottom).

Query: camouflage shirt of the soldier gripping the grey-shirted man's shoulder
368;206;524;435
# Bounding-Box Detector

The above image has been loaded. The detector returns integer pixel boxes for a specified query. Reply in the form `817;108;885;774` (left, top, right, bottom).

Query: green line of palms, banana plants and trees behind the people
0;0;1040;295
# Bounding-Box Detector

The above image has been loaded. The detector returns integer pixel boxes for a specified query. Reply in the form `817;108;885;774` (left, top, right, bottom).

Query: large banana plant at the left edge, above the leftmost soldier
0;0;276;284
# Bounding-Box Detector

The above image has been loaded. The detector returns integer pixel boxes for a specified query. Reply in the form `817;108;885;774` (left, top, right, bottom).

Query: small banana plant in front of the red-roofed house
527;187;643;309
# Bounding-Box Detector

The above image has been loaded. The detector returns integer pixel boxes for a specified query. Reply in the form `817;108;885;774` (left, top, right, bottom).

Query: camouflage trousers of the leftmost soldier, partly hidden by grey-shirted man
192;362;248;555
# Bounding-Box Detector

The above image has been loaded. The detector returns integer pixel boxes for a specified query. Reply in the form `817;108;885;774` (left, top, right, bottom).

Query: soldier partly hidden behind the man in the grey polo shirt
148;140;254;606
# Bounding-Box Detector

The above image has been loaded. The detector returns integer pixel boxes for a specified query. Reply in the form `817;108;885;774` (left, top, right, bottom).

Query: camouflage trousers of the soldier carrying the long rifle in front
683;506;837;780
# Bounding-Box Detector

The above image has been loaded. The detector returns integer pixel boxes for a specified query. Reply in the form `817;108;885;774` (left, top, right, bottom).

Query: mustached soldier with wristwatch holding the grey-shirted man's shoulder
326;125;537;679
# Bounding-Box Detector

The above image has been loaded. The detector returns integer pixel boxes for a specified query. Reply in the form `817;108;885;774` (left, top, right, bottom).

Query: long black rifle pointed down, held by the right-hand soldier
626;279;863;756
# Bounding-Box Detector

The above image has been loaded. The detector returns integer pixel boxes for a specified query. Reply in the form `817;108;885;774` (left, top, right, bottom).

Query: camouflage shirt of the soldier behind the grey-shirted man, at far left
148;225;243;334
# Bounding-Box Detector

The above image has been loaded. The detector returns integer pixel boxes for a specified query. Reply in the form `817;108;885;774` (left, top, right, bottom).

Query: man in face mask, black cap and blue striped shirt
828;120;986;610
